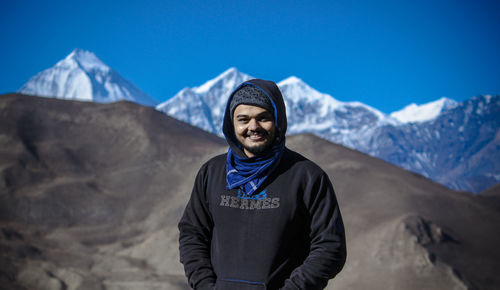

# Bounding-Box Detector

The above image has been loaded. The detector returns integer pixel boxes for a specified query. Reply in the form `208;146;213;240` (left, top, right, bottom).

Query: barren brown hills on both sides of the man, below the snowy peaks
0;94;500;290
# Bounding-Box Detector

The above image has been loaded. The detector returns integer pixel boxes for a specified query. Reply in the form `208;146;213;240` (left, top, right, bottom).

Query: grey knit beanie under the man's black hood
229;85;274;120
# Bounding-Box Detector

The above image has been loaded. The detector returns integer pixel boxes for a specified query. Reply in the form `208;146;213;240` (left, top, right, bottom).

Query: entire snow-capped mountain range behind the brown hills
19;49;500;192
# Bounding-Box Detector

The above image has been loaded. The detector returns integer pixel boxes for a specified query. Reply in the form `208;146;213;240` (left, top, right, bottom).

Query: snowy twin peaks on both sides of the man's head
157;68;397;147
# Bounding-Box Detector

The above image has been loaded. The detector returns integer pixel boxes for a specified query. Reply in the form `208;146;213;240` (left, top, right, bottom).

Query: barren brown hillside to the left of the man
0;95;224;290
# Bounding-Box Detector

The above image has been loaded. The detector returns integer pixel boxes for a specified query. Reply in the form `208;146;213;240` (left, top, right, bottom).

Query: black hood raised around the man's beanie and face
222;79;287;157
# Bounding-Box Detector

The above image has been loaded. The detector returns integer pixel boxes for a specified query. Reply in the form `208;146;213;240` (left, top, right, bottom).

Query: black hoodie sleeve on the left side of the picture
179;166;216;289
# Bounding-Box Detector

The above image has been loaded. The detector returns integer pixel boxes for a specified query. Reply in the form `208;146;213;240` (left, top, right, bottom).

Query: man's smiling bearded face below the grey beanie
233;105;276;157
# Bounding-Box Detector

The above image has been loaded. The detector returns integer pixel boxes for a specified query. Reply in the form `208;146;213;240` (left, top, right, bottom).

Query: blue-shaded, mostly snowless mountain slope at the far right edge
368;95;500;192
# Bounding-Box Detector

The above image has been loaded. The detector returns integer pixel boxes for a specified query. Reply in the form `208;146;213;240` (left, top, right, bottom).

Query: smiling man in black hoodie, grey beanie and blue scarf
179;79;346;290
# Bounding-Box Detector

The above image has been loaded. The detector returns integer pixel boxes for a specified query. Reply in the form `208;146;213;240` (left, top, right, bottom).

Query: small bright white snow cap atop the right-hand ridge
390;97;457;123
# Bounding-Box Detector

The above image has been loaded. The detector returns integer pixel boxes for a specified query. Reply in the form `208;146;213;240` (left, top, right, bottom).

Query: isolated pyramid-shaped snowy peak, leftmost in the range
18;49;157;106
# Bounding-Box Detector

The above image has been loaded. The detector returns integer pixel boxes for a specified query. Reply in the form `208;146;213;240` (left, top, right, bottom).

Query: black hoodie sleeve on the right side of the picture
282;173;346;290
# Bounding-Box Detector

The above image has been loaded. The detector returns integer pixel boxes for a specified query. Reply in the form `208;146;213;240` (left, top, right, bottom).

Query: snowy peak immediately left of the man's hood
156;68;252;136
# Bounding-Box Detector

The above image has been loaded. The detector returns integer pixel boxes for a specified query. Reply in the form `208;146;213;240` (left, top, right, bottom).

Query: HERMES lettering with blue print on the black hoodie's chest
219;190;280;210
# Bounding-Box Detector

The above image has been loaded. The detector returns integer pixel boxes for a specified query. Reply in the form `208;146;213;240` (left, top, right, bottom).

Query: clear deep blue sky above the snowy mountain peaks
0;0;500;113
